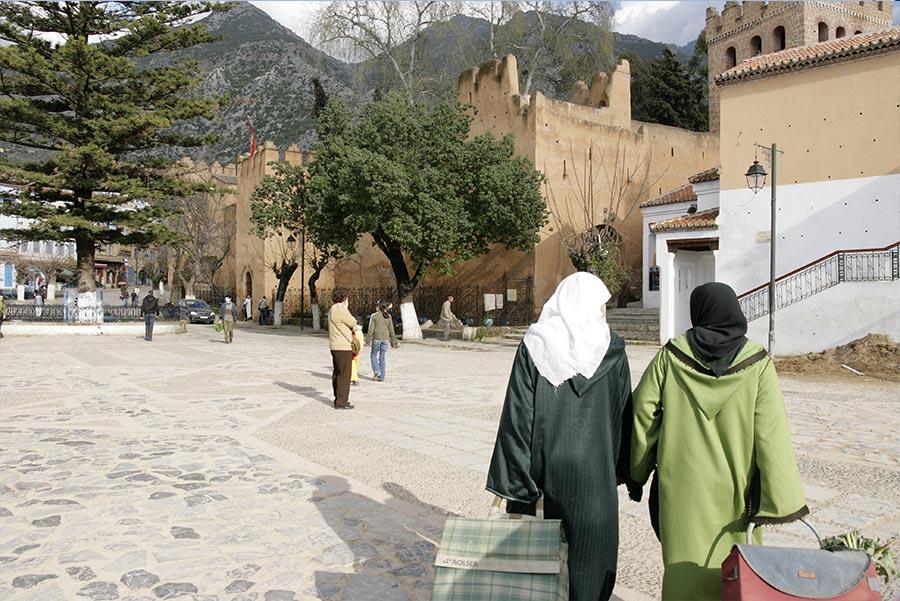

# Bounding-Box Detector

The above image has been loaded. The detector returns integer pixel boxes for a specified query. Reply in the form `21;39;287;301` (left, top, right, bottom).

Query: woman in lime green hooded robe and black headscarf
631;282;809;600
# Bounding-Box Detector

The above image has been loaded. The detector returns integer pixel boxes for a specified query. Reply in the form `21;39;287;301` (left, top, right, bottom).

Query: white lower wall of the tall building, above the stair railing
716;175;900;294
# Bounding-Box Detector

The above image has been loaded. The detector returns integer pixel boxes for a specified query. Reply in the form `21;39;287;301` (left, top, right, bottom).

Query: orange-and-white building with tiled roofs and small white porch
641;28;900;355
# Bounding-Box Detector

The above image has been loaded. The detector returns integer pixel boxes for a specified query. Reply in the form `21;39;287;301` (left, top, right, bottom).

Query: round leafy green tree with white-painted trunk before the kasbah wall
307;92;547;338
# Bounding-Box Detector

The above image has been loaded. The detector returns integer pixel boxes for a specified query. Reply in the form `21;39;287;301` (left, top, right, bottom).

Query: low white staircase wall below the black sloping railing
744;280;900;355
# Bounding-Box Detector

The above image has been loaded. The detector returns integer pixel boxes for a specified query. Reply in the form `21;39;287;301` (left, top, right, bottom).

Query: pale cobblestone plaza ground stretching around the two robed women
0;324;900;601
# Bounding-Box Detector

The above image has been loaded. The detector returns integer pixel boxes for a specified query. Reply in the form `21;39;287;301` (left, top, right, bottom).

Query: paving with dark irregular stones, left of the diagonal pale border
0;328;440;601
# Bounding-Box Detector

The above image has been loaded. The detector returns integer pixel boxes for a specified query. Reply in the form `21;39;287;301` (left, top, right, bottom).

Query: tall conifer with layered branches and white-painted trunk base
0;1;229;318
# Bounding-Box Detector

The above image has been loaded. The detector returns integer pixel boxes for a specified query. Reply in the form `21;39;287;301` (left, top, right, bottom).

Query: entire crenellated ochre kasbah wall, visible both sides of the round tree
225;55;719;312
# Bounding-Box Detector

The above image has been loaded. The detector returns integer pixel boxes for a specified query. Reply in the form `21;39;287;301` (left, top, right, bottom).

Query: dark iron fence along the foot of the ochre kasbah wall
272;275;534;326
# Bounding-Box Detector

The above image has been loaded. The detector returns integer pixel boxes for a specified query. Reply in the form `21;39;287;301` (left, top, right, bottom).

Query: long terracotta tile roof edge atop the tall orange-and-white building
716;27;900;85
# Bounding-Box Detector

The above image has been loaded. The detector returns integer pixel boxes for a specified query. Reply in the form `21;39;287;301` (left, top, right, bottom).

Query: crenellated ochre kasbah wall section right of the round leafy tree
458;55;719;310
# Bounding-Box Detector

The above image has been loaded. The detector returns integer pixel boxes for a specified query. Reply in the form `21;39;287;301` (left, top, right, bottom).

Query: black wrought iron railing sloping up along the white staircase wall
738;243;900;321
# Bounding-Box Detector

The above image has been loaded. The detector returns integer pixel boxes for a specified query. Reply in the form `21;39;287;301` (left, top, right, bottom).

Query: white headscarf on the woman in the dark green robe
525;272;610;386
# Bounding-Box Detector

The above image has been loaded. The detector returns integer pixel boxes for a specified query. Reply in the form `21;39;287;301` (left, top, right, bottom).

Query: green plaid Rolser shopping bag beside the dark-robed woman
431;500;569;601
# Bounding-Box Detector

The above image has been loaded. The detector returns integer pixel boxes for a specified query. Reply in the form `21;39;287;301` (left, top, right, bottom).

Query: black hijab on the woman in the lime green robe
686;282;747;376
